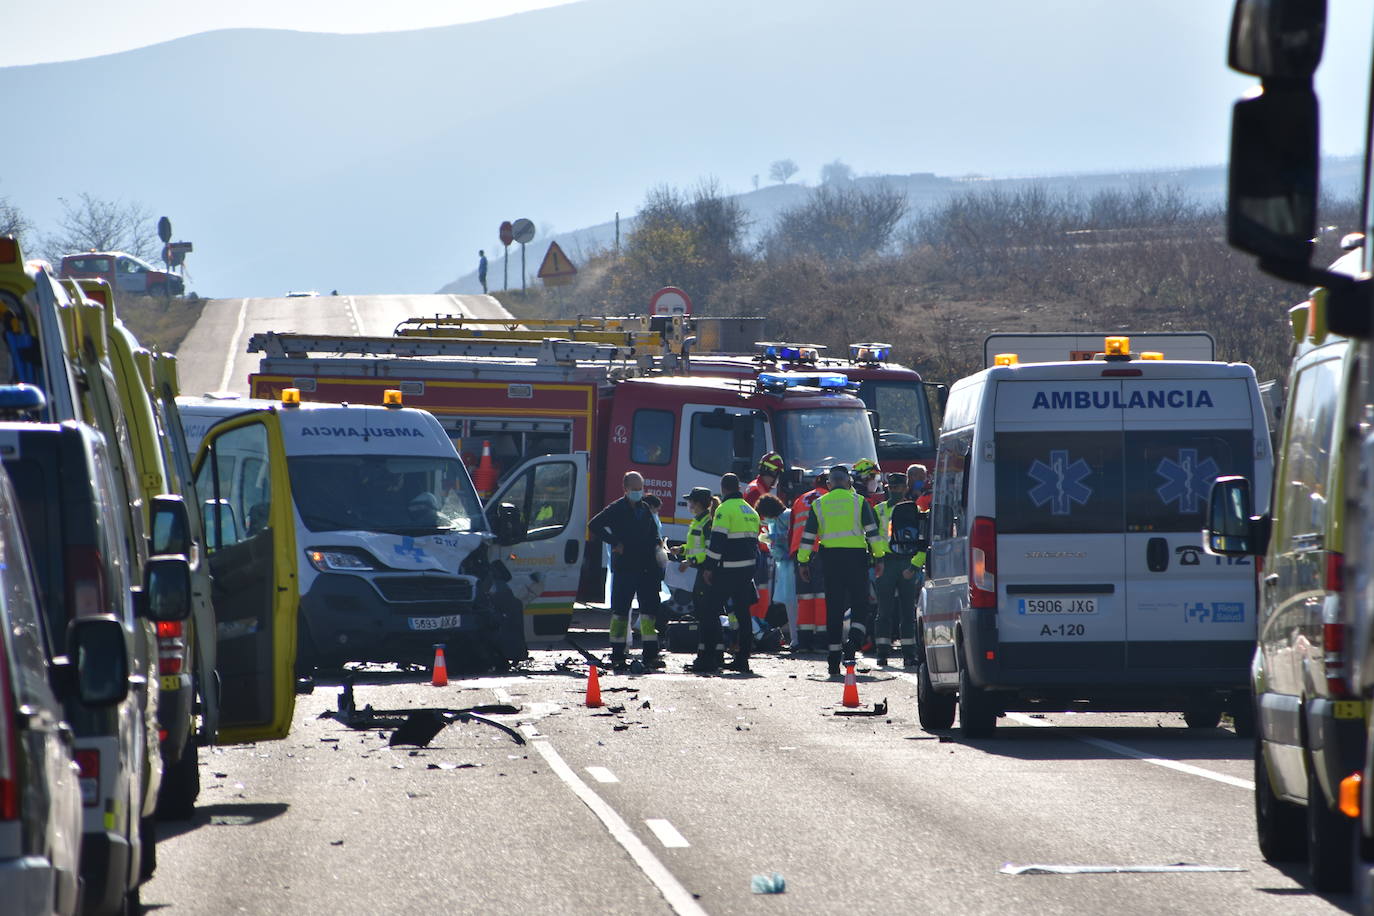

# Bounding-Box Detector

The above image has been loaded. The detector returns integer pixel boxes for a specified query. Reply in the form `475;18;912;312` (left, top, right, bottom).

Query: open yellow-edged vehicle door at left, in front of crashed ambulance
195;412;300;744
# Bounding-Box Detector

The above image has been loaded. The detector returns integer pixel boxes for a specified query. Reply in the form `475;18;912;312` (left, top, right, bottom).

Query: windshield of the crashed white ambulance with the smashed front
287;455;486;536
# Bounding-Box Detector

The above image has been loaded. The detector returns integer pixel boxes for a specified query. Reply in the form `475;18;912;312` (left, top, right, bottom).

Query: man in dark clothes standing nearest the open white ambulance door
587;471;662;674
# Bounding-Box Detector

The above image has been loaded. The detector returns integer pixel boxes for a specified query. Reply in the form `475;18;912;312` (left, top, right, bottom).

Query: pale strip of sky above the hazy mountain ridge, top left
0;0;574;67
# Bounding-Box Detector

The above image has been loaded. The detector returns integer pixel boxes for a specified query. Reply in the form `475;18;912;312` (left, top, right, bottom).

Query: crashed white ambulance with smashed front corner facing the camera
177;390;523;670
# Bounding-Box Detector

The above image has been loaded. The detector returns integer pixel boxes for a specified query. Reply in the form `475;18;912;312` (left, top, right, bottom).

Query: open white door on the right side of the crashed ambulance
488;452;589;643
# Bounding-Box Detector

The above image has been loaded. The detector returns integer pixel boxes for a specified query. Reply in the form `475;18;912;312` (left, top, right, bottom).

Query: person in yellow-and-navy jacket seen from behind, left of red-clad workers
702;474;760;674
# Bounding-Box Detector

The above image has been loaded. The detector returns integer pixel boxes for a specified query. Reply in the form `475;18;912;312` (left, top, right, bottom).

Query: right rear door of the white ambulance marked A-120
1123;376;1272;672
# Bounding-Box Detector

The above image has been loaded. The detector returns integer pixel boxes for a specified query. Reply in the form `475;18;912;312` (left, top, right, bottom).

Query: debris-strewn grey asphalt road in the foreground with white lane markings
143;637;1353;915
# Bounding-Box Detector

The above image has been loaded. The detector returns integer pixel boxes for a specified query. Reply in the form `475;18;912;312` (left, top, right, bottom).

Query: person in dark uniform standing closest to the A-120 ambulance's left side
874;474;926;670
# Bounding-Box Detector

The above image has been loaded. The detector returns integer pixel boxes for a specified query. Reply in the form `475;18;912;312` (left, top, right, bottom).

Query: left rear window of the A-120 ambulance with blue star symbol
996;430;1124;534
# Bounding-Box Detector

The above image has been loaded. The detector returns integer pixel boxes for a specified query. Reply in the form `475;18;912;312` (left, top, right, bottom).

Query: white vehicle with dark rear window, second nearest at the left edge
0;420;191;913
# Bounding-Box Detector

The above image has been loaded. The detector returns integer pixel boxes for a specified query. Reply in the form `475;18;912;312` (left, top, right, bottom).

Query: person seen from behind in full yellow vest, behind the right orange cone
797;464;888;678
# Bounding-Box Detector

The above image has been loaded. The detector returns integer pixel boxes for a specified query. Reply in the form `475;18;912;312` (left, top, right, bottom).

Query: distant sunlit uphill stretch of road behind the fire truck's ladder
177;295;510;394
